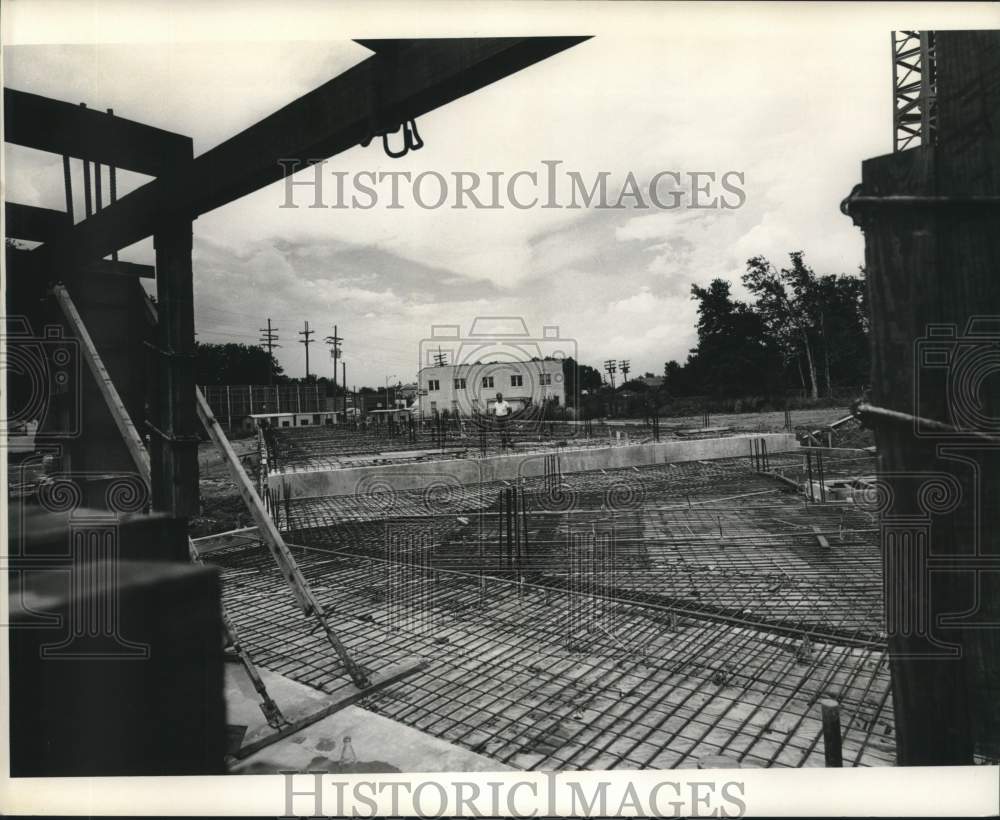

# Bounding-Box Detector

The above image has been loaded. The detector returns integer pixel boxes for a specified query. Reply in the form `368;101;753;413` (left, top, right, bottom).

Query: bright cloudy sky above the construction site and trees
4;3;988;385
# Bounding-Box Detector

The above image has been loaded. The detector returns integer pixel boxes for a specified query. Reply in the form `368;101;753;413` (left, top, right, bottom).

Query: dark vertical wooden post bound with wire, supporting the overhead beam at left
150;218;198;518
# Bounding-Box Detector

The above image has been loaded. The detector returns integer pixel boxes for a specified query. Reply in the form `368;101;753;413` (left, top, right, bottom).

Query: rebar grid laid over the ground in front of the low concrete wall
211;452;894;769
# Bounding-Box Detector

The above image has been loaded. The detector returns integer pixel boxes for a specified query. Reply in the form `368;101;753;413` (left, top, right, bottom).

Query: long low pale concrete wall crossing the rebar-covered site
268;433;800;501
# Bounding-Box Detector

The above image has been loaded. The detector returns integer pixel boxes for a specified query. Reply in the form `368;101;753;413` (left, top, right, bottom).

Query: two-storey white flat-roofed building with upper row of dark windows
417;359;566;417
